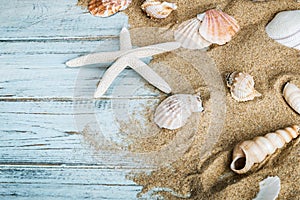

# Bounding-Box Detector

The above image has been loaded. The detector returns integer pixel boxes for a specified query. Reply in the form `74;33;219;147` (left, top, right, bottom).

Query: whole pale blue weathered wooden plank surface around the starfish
0;0;161;199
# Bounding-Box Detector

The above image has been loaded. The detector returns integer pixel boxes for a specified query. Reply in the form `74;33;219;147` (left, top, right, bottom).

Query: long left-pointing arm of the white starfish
66;51;122;67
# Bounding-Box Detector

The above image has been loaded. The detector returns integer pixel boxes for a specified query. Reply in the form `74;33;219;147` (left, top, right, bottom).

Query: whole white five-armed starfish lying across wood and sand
66;27;180;98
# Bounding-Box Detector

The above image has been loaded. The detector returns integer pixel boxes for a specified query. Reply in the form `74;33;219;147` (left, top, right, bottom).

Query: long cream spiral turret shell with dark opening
230;125;300;174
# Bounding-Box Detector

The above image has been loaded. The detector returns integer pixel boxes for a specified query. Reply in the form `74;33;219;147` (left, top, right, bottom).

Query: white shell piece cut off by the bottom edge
253;176;280;200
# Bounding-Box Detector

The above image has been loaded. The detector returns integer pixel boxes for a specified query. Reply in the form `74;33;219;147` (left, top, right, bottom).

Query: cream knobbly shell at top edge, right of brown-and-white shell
141;0;177;19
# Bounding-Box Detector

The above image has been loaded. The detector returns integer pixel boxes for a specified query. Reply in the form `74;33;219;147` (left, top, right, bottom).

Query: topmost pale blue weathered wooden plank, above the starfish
0;0;128;40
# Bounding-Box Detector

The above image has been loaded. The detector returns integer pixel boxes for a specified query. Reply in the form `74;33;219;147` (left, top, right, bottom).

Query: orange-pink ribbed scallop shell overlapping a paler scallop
199;9;240;45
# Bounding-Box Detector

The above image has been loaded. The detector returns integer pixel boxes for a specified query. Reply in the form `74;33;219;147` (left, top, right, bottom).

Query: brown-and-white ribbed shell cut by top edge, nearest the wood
88;0;131;17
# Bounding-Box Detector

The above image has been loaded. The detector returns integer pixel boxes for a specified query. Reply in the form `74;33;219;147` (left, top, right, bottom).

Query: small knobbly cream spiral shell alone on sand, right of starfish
226;72;261;101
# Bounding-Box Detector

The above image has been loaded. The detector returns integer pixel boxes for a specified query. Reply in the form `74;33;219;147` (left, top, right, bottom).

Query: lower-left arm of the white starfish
94;57;128;98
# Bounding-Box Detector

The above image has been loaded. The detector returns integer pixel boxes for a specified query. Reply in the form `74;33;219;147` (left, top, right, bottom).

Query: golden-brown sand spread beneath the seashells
78;0;300;200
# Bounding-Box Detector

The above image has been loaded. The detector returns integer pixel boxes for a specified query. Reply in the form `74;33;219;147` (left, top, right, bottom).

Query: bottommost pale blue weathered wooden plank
0;166;141;200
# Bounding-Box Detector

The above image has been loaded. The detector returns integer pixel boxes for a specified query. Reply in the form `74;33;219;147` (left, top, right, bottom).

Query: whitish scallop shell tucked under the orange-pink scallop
174;18;211;49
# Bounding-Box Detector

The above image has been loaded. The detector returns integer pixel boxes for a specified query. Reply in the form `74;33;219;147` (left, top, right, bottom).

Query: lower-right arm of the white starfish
127;57;171;93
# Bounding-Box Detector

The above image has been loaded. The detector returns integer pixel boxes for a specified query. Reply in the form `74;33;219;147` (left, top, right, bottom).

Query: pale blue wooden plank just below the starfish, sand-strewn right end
0;99;159;168
